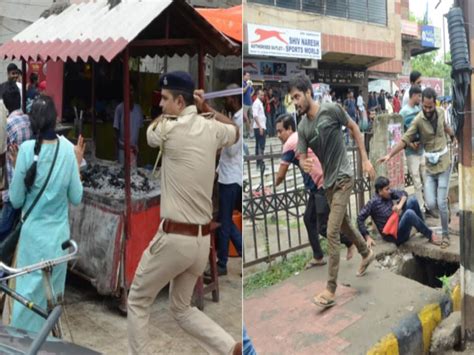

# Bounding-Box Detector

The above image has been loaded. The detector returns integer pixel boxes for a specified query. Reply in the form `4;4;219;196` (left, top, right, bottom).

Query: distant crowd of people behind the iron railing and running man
242;71;452;175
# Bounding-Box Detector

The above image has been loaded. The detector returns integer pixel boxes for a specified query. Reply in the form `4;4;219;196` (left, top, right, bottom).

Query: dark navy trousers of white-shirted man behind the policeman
217;183;242;269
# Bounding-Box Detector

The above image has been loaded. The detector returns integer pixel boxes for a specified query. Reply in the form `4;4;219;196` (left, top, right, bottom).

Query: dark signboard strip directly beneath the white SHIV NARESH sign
243;58;305;81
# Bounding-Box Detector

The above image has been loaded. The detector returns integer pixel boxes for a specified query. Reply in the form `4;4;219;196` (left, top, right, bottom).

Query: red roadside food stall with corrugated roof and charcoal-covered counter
0;0;241;306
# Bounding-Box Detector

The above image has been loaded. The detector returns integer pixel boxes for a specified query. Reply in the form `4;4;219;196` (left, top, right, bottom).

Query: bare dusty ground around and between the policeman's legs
62;258;242;355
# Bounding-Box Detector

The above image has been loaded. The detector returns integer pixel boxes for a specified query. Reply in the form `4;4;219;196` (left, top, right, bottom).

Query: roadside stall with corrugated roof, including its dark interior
0;0;241;308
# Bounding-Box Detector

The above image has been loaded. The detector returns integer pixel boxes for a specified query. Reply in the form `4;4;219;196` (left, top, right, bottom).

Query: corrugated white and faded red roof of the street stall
0;0;239;62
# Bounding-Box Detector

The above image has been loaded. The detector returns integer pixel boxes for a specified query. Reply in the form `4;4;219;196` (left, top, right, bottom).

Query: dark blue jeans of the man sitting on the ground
384;196;433;246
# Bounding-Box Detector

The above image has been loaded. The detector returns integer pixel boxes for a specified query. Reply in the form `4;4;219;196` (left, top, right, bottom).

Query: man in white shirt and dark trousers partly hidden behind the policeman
217;84;243;276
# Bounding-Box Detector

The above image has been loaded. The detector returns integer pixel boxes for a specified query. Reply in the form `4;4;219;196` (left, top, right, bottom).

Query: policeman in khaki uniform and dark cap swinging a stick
127;72;241;355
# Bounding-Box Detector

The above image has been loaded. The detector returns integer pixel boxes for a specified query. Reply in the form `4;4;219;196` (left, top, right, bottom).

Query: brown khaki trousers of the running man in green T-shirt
326;178;369;293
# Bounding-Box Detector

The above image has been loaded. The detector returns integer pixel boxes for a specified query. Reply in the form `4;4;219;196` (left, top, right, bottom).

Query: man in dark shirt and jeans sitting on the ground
357;176;441;246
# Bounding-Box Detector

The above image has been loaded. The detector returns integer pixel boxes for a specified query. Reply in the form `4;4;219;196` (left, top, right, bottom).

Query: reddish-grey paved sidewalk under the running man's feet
244;256;443;354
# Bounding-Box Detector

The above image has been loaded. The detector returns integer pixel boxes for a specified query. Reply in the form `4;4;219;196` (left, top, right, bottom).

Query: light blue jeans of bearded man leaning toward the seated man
425;166;451;237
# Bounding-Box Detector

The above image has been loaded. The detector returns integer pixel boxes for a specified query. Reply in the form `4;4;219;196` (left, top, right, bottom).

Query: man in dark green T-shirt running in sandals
289;74;375;308
